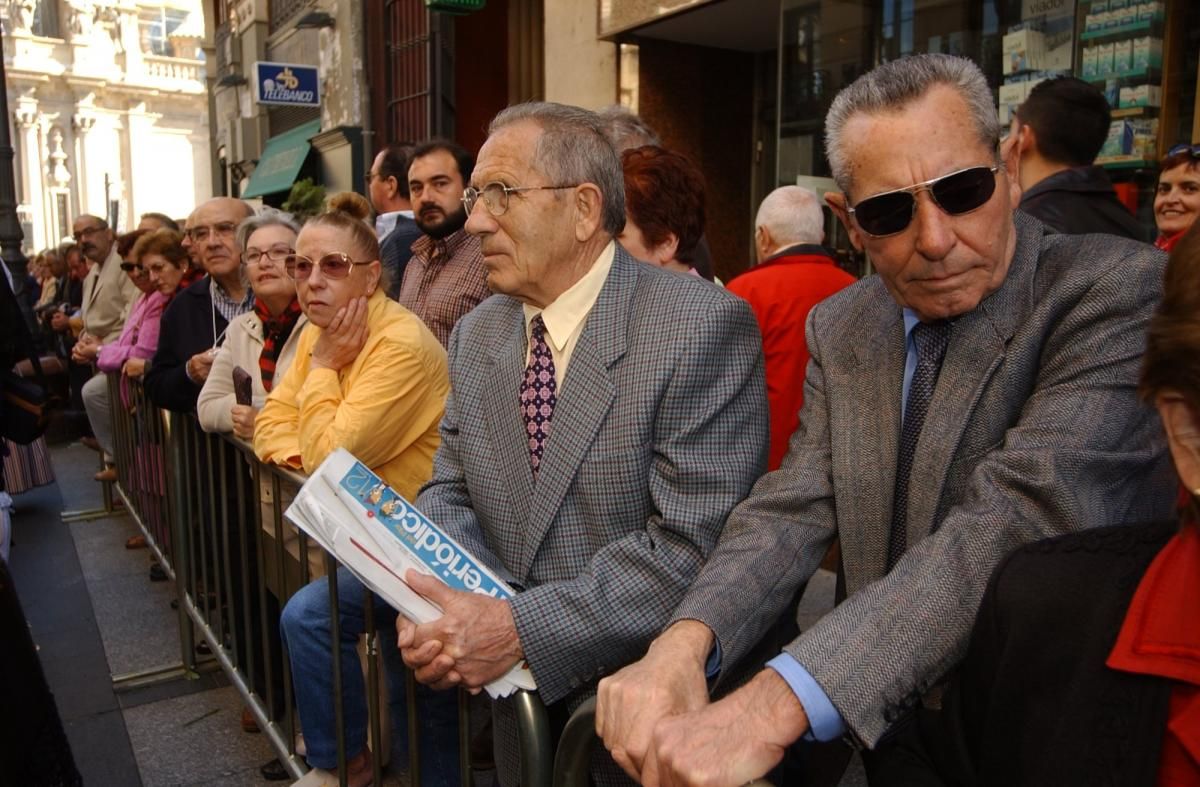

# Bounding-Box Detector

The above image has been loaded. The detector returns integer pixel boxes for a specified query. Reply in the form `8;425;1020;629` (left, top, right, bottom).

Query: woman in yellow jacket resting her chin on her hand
254;194;450;499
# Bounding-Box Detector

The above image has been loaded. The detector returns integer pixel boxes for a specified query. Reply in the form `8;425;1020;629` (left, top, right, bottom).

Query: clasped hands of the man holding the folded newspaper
396;570;524;693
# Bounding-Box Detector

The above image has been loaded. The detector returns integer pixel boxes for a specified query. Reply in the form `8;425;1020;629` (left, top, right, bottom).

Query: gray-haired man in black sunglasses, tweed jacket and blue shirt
596;55;1172;785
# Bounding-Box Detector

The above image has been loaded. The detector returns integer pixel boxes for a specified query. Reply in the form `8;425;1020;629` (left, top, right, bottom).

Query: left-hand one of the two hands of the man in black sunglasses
596;620;712;781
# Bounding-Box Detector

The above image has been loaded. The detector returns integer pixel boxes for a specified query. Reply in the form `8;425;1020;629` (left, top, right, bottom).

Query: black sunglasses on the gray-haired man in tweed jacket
847;164;1000;238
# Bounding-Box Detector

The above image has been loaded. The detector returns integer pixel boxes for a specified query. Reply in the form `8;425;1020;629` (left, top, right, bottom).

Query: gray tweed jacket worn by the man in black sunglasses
674;212;1177;745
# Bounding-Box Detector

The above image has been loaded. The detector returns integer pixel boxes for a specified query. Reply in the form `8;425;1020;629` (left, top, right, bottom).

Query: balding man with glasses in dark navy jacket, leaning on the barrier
145;197;254;413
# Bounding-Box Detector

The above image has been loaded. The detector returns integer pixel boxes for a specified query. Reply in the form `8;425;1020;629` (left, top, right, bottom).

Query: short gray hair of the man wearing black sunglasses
826;54;1000;193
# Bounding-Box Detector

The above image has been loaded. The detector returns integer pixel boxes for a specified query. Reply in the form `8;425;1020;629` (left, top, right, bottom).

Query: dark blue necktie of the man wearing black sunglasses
888;320;952;571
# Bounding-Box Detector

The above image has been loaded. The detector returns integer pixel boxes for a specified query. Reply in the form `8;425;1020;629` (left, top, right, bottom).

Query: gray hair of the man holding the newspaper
487;101;625;235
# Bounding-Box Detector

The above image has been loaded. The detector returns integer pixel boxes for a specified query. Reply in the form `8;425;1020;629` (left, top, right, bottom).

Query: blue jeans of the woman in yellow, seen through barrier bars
280;567;460;787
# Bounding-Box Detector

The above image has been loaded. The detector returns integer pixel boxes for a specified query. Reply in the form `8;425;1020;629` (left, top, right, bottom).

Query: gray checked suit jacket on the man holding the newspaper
418;246;768;783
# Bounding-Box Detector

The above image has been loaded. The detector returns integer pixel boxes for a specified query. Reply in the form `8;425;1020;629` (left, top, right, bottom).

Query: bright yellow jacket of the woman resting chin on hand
254;289;450;500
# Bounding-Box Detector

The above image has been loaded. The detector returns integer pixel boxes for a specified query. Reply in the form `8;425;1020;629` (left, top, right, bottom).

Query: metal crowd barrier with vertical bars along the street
109;374;568;787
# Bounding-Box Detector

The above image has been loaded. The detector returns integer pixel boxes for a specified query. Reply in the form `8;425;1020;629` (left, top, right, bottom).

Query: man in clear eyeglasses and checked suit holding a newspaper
398;103;767;786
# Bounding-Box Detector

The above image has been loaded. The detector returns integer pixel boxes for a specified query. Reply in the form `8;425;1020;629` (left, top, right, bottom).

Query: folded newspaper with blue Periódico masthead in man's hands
287;449;536;698
